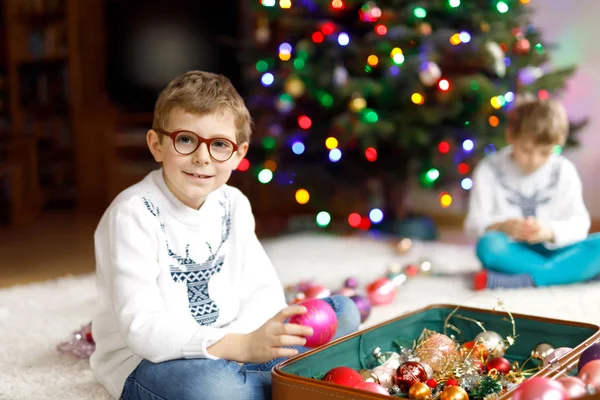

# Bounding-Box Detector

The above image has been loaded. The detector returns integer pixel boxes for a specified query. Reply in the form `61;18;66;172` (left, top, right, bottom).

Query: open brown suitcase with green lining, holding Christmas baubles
272;304;600;400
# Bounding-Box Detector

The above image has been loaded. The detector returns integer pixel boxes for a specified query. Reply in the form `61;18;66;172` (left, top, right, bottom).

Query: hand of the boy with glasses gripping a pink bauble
243;305;313;363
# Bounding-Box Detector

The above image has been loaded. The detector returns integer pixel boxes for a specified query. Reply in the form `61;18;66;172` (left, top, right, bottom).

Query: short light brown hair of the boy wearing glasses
152;71;252;143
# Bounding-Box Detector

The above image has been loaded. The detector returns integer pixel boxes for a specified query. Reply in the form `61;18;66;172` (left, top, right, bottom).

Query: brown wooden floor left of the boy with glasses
0;213;99;287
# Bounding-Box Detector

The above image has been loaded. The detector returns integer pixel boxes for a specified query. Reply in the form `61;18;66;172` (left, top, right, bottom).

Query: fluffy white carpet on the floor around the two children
0;235;600;400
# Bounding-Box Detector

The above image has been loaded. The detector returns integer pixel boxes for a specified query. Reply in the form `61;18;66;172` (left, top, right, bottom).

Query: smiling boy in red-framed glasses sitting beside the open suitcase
90;71;360;400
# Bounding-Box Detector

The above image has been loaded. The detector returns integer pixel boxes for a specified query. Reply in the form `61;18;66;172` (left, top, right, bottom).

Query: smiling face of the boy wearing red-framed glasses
147;109;248;209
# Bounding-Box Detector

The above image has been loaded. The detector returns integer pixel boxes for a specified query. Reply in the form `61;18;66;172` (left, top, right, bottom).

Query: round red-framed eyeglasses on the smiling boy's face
156;129;238;162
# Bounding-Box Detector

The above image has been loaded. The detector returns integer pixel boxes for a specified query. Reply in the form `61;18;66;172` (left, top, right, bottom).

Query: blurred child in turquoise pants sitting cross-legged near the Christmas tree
465;100;600;290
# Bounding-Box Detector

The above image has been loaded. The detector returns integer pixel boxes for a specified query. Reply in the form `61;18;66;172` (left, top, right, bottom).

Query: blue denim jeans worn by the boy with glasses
122;296;360;400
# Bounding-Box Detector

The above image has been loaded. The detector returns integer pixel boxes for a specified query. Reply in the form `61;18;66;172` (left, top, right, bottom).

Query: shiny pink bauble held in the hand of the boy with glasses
289;299;337;347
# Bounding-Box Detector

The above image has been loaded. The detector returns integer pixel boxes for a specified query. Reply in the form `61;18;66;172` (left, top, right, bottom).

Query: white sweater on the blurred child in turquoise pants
465;146;590;249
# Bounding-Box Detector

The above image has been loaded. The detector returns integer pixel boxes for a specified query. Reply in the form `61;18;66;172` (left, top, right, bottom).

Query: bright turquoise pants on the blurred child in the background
477;232;600;286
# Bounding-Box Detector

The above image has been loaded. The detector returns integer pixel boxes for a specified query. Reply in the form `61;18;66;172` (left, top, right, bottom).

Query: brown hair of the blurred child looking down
507;99;569;144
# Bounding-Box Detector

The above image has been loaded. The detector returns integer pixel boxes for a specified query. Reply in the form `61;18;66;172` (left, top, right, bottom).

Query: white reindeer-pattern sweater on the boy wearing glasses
90;170;286;398
